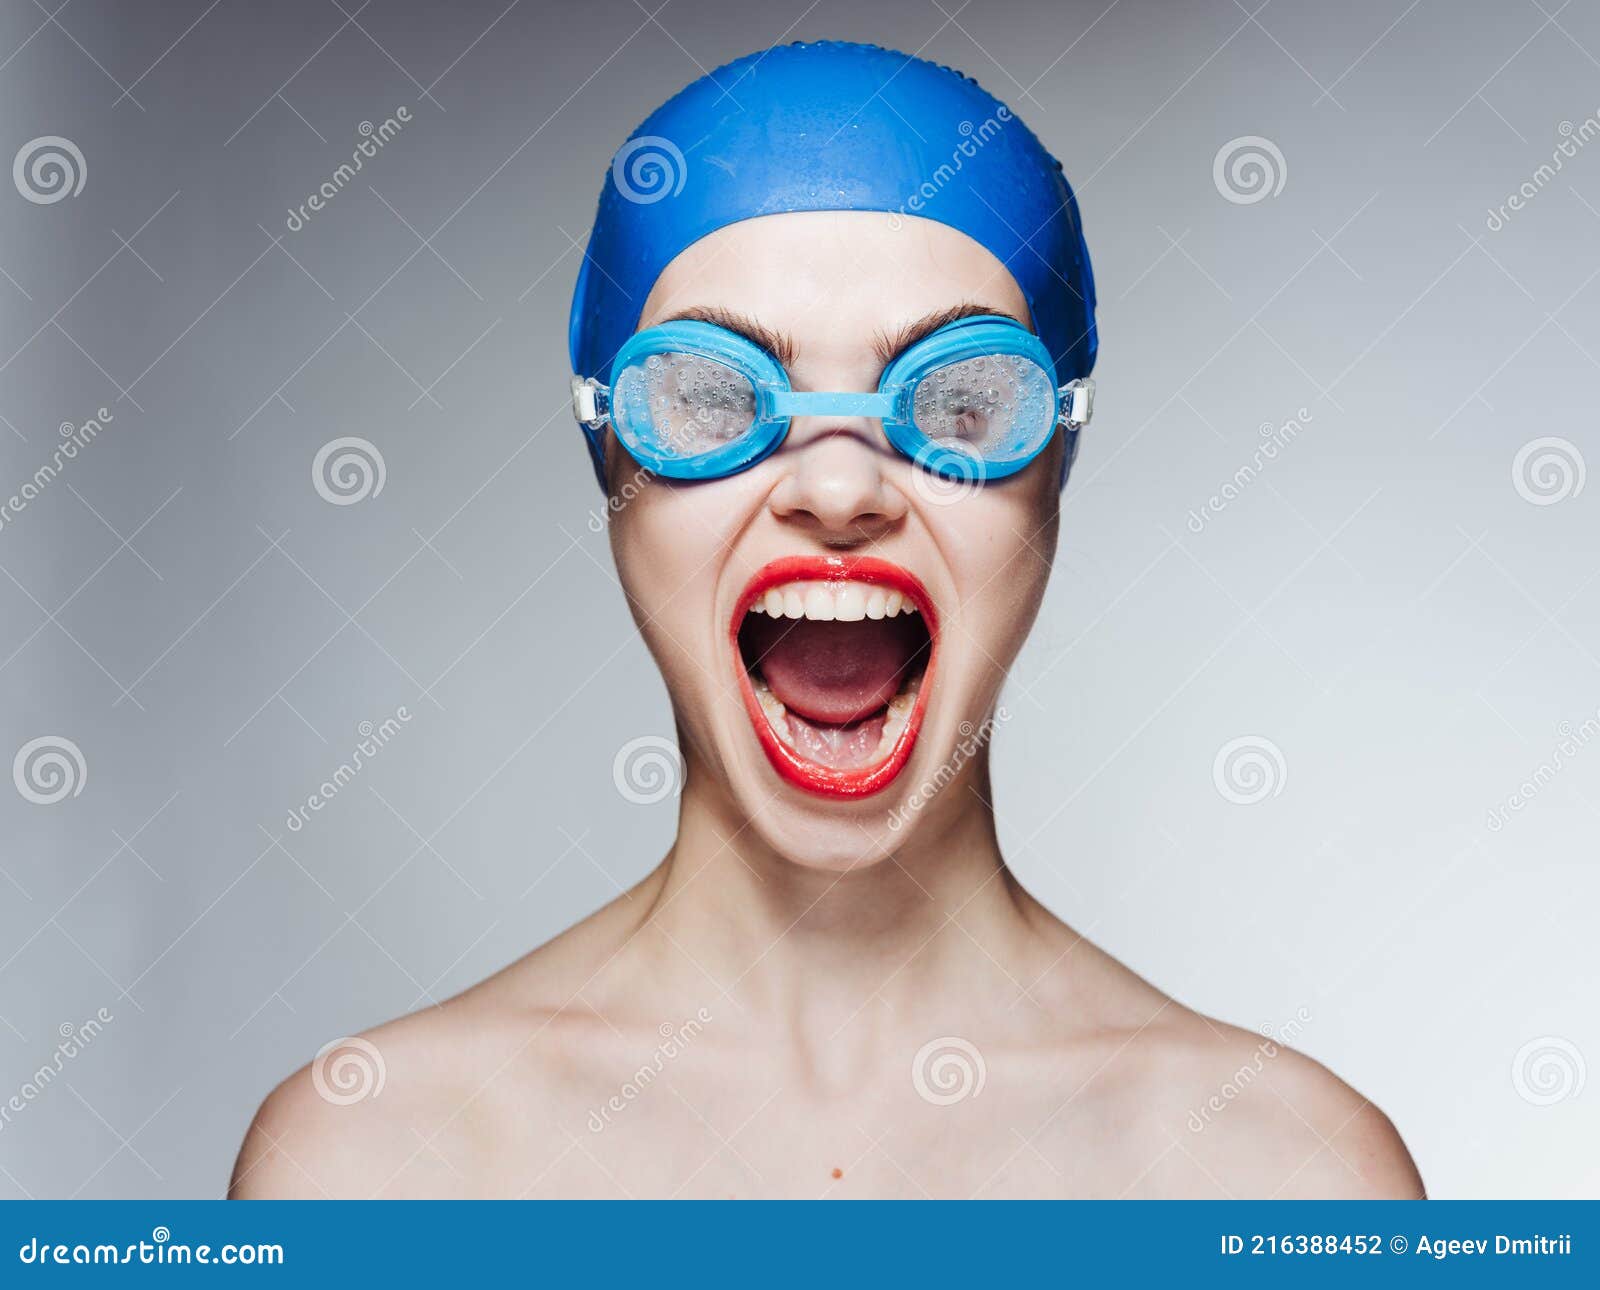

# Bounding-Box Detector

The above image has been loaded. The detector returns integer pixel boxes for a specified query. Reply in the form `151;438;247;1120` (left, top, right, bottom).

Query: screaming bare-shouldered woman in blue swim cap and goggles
232;43;1421;1197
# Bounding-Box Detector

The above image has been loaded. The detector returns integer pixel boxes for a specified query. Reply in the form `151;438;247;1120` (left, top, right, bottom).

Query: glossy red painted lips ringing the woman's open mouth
728;555;939;800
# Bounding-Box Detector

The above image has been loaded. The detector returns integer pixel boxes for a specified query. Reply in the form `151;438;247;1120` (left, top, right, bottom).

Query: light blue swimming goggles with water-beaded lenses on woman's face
573;314;1094;482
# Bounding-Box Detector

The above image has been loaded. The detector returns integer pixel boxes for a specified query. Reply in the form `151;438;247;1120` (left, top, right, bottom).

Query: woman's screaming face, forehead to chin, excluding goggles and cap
608;211;1062;869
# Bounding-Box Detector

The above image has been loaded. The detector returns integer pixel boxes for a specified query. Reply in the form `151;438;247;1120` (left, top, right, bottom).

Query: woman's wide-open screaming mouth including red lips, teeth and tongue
731;555;939;797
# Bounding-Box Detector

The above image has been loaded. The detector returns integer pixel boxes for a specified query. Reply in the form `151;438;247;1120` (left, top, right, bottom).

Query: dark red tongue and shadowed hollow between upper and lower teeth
747;615;926;725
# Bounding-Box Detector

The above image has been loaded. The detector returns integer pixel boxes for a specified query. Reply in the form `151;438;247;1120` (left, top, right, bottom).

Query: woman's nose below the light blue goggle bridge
768;418;907;544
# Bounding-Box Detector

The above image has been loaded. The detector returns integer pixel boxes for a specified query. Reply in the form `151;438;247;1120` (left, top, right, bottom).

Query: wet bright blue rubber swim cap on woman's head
568;40;1096;487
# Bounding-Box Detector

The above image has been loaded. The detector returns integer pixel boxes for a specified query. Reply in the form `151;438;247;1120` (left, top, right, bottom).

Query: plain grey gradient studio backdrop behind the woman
0;0;1600;1196
